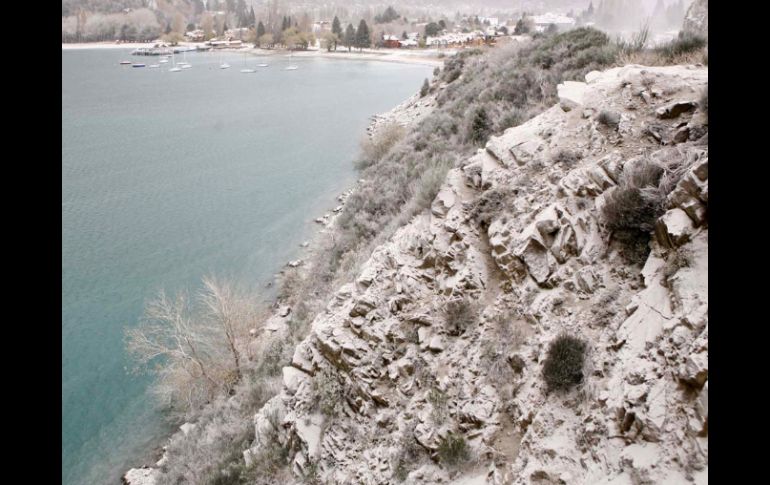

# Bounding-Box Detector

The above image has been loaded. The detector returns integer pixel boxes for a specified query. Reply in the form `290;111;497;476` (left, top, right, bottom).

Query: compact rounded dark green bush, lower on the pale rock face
543;335;586;391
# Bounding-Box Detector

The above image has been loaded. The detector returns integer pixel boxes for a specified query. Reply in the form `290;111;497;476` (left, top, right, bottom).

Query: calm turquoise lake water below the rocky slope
62;50;432;485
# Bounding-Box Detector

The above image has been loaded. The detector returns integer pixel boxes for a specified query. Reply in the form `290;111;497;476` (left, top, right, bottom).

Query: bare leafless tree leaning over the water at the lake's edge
126;278;257;413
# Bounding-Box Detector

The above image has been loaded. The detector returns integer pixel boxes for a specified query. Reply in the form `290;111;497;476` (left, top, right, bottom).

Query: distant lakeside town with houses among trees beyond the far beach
62;0;684;55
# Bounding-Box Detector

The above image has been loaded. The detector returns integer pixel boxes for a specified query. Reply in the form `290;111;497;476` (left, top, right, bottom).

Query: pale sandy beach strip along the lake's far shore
61;42;450;67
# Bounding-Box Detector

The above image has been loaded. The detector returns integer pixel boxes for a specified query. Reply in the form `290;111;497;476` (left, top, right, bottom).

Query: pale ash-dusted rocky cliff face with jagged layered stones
244;62;708;484
